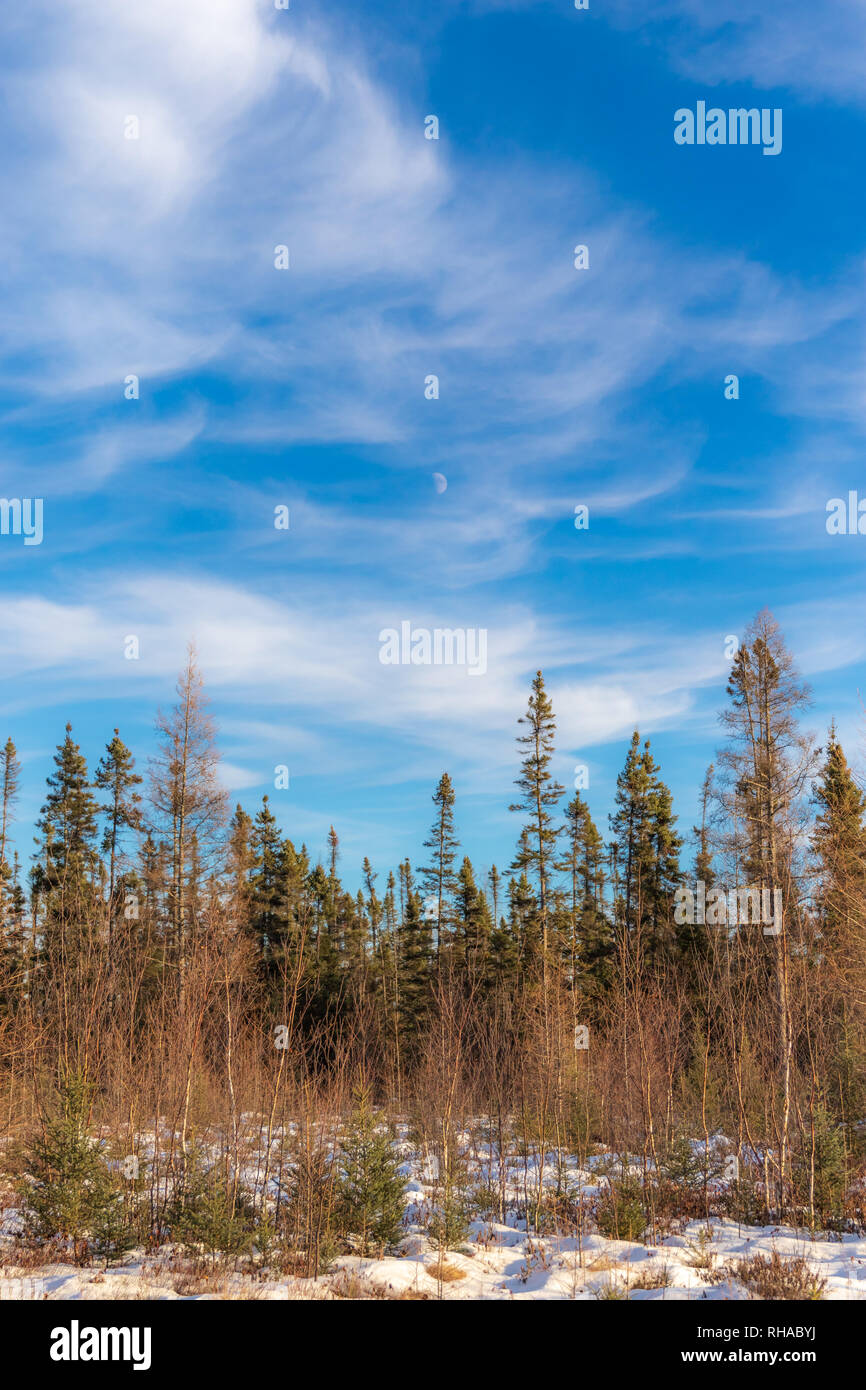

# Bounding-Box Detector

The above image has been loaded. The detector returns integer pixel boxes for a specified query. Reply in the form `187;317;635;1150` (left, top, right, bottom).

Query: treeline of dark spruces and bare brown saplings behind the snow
0;612;866;1225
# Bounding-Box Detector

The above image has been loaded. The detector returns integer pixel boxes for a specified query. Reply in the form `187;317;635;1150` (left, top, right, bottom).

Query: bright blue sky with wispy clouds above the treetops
0;0;866;881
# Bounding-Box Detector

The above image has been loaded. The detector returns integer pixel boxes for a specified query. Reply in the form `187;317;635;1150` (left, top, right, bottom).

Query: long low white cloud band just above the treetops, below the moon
0;574;828;767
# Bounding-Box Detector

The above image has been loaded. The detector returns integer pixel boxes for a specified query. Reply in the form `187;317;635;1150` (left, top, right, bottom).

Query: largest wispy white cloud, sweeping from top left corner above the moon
0;0;852;517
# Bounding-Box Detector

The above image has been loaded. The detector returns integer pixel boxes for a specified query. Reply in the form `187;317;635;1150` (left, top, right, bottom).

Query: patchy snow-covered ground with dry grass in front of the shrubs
0;1128;866;1301
